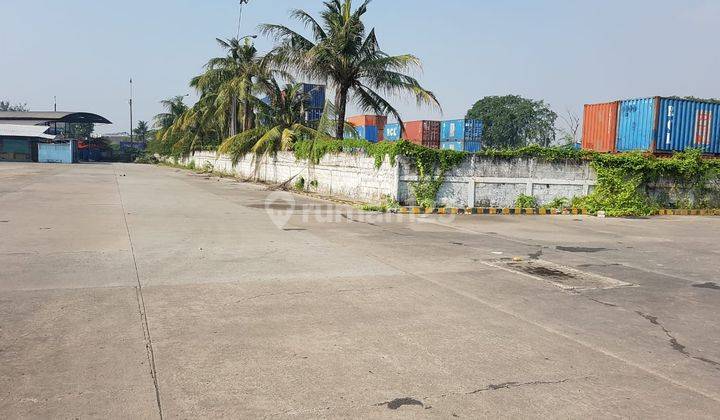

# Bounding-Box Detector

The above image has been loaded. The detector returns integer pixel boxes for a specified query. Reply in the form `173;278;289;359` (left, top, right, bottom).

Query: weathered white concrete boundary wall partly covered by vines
187;152;596;207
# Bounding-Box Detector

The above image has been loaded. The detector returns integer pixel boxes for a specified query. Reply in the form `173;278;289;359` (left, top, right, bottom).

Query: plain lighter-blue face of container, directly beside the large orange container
615;98;657;152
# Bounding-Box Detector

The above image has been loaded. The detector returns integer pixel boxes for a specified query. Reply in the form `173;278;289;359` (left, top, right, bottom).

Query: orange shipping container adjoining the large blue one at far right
582;102;620;152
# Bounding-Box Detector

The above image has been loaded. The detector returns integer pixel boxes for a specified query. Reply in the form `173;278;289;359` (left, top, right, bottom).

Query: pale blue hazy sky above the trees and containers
0;0;720;132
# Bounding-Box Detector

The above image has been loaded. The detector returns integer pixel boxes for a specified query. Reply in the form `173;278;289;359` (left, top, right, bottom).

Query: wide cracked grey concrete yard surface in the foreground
0;163;720;418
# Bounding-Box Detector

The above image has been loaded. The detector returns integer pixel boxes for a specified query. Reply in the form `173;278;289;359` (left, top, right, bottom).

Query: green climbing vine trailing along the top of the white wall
295;139;720;216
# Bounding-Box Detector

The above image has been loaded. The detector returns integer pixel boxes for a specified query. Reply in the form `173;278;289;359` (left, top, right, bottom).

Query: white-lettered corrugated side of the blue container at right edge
655;98;720;154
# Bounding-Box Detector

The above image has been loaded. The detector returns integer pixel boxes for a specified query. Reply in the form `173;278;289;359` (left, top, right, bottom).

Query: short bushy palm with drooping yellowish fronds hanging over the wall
218;79;328;164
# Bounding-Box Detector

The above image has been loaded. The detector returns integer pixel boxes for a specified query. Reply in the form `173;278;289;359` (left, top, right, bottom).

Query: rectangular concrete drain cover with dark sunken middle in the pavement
491;260;635;291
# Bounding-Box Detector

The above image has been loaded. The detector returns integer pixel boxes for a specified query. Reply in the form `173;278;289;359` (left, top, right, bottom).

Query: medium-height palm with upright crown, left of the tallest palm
190;38;267;136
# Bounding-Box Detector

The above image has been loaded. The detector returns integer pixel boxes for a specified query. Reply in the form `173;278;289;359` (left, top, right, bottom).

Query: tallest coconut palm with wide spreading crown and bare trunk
261;0;440;138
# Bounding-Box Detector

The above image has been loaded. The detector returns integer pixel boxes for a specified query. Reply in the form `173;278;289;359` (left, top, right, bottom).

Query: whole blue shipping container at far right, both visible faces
617;98;720;154
